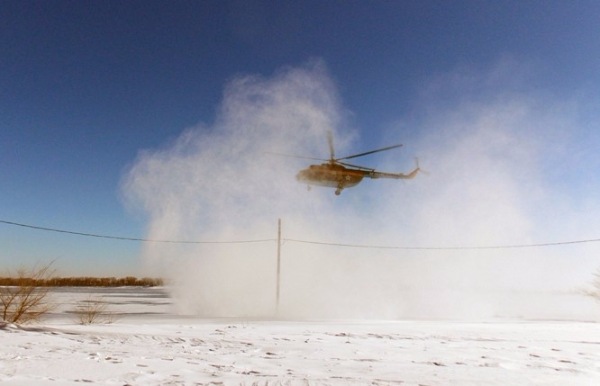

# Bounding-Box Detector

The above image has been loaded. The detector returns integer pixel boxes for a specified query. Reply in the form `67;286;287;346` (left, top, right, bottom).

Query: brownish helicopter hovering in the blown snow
276;132;421;196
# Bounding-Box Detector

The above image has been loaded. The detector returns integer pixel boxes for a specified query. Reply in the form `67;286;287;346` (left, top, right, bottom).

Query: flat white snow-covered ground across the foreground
0;288;600;385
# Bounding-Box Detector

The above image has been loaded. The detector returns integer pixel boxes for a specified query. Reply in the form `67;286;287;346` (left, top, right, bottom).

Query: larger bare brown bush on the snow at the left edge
0;263;54;323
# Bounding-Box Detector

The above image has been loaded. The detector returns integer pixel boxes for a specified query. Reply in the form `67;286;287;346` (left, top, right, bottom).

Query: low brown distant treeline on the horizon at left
0;276;164;287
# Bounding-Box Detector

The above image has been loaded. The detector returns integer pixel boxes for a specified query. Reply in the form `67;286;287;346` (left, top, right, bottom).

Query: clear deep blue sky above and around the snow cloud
0;0;600;275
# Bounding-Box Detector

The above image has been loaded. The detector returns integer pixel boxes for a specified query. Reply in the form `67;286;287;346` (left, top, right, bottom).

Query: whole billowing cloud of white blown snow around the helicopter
124;62;600;318
